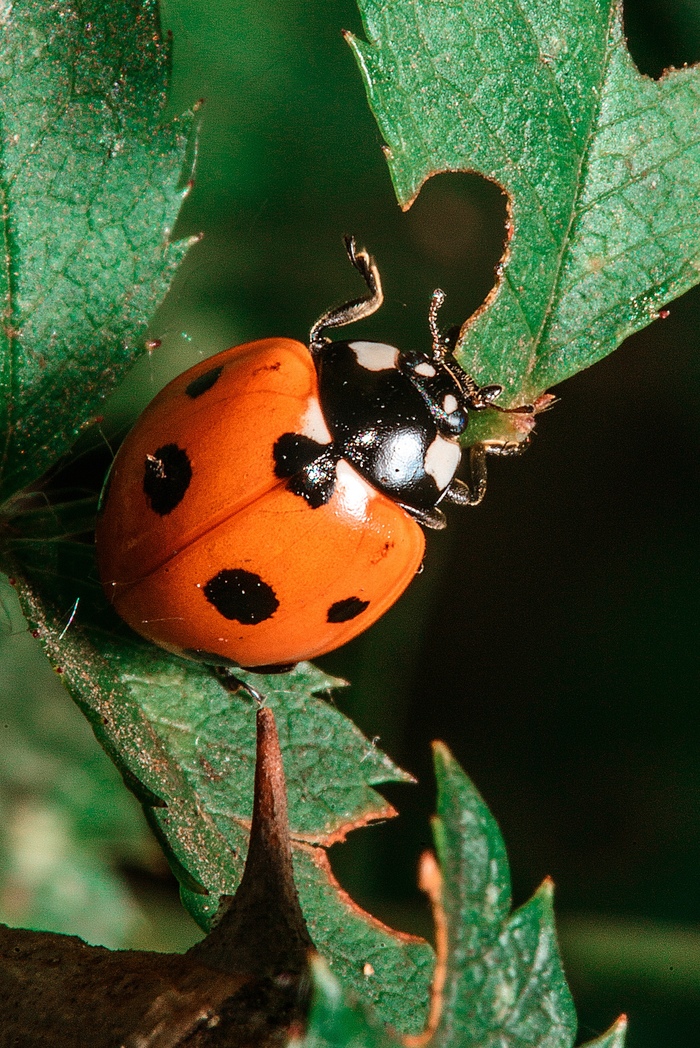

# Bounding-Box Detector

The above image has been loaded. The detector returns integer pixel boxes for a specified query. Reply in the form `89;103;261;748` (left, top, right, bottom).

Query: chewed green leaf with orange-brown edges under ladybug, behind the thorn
13;540;434;1032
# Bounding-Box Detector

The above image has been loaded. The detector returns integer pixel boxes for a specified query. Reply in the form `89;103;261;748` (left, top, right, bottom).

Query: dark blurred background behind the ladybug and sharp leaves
1;0;700;1048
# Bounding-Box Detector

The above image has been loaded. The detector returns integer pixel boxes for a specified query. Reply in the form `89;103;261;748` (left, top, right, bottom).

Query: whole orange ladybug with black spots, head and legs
96;238;532;671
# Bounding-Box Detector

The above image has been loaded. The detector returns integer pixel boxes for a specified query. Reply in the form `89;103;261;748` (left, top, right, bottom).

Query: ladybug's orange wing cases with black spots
96;339;424;668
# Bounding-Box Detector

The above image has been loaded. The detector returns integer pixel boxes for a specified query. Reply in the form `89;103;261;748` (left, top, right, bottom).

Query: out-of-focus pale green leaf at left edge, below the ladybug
0;581;152;947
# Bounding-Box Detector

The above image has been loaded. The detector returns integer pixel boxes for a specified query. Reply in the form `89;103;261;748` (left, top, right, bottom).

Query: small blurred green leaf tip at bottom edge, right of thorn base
289;958;400;1048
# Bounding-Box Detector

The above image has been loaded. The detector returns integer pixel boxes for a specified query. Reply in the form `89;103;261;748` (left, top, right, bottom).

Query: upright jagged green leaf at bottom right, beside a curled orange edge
433;744;576;1048
